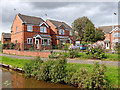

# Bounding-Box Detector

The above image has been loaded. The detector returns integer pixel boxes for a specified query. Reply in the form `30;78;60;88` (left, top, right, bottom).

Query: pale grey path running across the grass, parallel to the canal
0;53;120;66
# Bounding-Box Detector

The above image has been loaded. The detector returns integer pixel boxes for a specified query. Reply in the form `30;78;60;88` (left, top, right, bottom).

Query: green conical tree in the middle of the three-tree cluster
84;22;95;42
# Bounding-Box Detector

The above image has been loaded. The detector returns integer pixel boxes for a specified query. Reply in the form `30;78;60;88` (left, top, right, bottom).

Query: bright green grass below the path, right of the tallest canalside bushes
67;63;119;88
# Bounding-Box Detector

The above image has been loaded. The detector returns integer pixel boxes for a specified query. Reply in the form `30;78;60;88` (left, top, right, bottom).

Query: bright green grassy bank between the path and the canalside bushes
0;56;118;88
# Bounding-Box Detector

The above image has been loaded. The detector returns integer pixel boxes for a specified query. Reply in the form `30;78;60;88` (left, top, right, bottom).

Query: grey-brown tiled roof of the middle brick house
47;19;72;29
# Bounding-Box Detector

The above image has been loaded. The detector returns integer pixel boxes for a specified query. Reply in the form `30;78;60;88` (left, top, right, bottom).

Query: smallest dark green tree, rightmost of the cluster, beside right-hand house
95;28;105;42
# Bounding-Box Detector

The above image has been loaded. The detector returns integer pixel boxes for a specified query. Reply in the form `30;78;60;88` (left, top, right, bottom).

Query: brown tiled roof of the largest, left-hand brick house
18;13;45;25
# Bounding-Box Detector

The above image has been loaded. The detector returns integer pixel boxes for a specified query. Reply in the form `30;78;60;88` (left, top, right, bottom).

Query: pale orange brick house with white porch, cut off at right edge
99;25;120;49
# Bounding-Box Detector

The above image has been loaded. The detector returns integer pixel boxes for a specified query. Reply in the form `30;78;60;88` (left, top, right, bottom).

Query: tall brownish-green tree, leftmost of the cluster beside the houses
72;16;91;41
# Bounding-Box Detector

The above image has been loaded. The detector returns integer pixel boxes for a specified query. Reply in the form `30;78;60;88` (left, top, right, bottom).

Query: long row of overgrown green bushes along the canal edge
24;57;110;89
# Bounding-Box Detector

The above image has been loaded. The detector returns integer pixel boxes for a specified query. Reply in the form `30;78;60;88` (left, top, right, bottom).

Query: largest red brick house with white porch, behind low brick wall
11;14;52;50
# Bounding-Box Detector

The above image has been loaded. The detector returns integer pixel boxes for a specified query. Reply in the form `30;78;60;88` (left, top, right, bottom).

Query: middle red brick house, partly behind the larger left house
46;19;75;45
